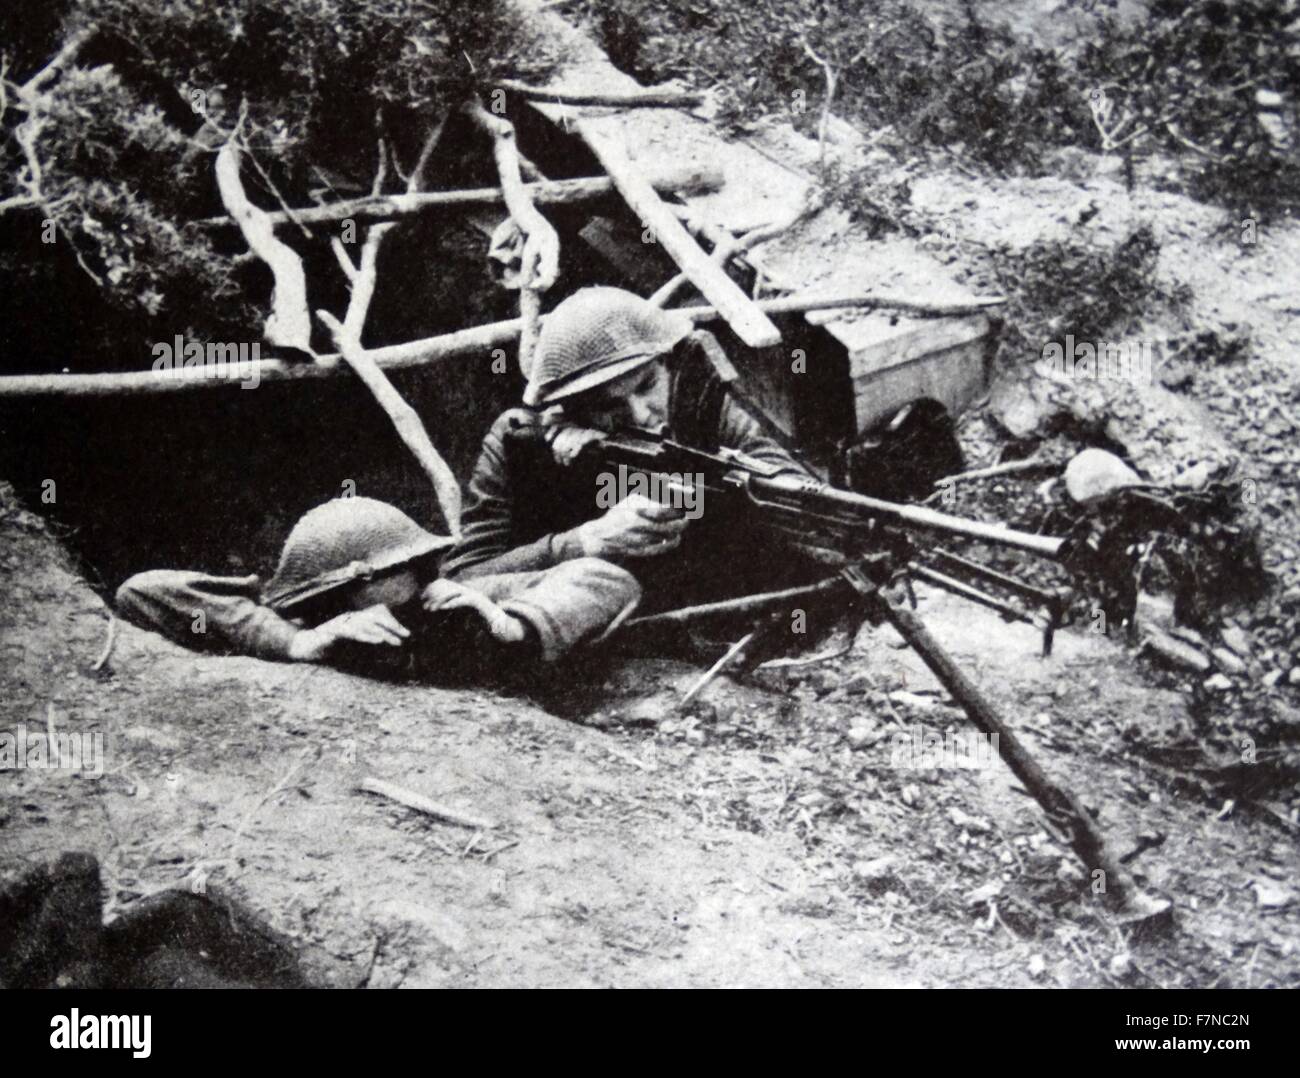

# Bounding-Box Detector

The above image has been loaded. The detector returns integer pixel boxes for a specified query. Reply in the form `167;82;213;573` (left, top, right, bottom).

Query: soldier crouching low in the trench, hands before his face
117;497;640;679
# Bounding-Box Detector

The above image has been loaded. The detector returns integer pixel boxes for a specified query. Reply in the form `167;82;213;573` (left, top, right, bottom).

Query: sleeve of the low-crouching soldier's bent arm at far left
117;570;300;661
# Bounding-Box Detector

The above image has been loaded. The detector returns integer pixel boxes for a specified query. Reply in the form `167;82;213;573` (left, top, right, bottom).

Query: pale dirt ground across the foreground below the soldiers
0;468;1300;987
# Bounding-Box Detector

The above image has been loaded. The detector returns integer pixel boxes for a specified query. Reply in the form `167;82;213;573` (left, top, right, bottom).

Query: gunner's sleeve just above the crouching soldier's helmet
442;410;582;579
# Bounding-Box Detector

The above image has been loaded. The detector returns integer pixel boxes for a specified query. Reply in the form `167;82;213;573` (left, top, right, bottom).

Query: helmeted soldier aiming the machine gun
443;287;802;607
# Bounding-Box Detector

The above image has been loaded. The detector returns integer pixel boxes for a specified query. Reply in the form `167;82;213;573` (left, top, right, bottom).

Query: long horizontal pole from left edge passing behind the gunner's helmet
0;293;1006;399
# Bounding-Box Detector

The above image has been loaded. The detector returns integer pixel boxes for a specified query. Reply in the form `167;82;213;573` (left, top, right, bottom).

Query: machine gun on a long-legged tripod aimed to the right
589;348;1171;921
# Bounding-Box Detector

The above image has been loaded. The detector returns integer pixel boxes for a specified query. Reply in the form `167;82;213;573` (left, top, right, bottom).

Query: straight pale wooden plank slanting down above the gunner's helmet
575;120;781;348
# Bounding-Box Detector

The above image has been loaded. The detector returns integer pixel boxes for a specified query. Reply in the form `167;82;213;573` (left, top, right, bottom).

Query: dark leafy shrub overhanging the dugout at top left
0;0;553;366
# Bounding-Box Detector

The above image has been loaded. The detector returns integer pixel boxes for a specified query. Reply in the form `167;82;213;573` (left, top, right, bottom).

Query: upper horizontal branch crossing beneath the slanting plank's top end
196;165;723;228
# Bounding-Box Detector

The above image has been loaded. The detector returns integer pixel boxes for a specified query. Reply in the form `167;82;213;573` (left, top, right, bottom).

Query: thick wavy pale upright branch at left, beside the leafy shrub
216;134;312;351
